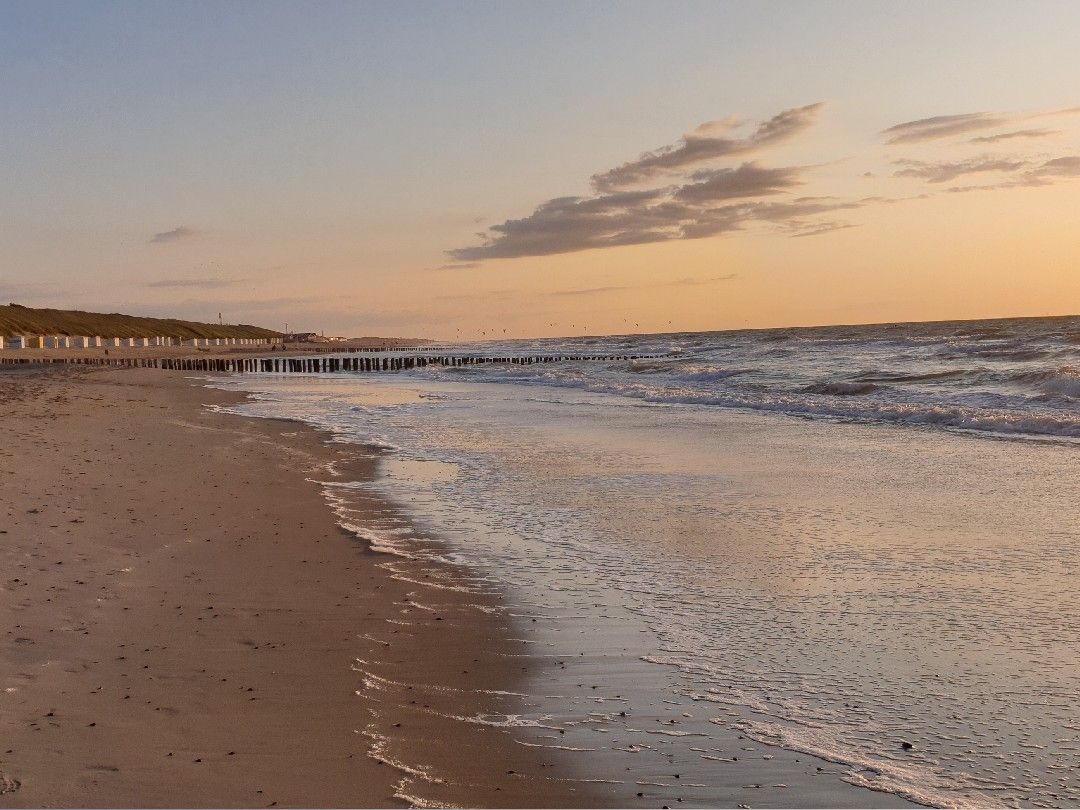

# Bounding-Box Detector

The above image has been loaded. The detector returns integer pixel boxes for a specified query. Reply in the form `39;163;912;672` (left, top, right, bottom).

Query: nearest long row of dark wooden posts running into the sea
0;354;654;374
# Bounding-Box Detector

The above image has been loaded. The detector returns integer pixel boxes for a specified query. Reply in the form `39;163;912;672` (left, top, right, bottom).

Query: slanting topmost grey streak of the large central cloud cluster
592;102;824;193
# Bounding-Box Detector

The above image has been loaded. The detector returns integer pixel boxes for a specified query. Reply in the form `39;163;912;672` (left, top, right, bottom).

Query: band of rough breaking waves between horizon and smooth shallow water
406;318;1080;440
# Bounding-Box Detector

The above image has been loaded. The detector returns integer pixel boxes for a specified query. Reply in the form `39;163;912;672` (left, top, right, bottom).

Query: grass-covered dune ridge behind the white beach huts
0;303;281;340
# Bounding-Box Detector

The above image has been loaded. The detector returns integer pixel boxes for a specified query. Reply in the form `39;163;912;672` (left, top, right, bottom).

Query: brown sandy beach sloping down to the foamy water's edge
0;367;603;807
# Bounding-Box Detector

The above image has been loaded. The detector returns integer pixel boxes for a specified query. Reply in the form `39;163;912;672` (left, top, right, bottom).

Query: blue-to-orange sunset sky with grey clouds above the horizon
0;0;1080;340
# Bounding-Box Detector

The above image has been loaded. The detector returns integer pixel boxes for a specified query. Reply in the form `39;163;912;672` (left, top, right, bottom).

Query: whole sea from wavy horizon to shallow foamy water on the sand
215;318;1080;807
